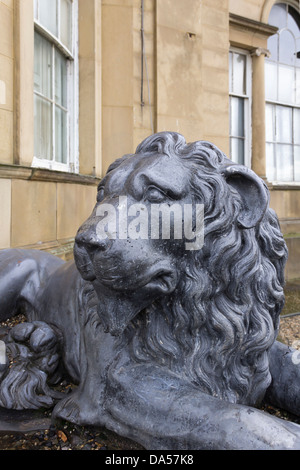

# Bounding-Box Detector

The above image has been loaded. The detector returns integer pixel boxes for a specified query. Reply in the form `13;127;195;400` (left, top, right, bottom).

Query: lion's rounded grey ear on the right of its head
222;164;269;229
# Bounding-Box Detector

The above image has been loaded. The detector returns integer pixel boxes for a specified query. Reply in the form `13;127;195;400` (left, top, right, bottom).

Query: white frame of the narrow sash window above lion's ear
229;47;252;168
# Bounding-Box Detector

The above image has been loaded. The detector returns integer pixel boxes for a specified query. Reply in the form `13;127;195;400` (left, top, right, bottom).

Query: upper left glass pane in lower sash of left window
34;33;52;98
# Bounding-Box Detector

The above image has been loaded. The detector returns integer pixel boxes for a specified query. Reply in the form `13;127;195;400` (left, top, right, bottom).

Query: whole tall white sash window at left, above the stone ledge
33;0;78;171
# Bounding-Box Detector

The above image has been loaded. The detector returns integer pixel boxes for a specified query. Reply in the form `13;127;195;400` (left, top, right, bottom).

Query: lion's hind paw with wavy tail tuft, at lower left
0;321;62;409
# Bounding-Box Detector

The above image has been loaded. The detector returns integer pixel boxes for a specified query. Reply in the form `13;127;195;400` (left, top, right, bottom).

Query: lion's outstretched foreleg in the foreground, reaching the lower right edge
105;365;300;450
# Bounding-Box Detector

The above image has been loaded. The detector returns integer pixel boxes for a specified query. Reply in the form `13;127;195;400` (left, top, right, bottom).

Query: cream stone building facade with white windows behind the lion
0;0;300;279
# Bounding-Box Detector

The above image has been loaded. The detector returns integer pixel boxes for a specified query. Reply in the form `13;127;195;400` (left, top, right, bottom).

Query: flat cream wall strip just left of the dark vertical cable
102;0;133;172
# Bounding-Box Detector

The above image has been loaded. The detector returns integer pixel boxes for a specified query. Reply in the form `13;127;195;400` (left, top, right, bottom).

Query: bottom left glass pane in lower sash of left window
34;95;52;160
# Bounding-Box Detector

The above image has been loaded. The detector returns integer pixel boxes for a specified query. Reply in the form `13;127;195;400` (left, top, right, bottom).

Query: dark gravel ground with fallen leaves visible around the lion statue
0;284;300;451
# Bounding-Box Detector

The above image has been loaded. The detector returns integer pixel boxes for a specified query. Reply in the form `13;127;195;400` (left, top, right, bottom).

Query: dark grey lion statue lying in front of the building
0;132;300;450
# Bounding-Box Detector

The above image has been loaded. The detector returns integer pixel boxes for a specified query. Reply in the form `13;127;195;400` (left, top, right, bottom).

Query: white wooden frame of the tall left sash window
32;0;79;173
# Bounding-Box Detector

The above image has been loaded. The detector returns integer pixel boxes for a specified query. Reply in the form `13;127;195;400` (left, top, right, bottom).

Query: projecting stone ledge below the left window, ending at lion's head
0;164;100;186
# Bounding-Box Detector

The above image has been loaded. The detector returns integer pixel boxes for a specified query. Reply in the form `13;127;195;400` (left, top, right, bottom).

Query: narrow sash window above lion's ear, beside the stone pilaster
229;50;251;166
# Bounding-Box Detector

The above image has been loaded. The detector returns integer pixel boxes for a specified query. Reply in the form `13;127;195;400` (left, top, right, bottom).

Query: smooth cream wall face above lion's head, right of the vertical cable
156;0;203;140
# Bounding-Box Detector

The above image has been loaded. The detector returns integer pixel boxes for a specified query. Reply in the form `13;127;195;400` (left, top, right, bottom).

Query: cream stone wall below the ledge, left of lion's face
0;174;97;259
